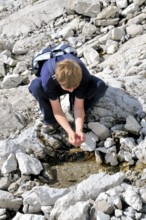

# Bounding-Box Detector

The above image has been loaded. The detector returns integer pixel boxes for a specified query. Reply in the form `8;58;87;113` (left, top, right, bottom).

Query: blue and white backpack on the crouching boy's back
32;43;77;76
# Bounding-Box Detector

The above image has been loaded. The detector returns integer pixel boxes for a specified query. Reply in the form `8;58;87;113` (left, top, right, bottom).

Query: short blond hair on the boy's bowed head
55;59;82;89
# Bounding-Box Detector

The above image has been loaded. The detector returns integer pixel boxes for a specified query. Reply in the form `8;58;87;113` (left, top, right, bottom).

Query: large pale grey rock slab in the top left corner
0;0;64;37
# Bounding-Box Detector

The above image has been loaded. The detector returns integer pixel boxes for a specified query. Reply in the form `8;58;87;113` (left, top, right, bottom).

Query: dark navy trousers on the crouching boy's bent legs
29;76;107;124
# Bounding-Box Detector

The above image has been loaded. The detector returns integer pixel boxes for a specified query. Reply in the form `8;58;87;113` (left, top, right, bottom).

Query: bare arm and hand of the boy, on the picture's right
74;97;85;144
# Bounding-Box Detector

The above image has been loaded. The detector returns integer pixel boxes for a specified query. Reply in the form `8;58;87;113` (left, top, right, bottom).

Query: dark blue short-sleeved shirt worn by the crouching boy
41;54;91;100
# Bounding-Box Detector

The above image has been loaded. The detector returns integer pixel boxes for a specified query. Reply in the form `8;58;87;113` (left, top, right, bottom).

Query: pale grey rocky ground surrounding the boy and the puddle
0;0;146;220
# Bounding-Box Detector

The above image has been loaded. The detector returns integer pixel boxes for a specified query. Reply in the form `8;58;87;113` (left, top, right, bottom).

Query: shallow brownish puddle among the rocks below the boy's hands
49;149;146;188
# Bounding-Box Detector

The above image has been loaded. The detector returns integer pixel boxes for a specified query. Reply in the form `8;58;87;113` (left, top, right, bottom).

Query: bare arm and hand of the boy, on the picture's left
50;99;76;146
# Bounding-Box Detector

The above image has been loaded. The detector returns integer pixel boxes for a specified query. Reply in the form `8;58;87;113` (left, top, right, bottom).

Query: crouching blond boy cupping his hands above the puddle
29;54;107;146
